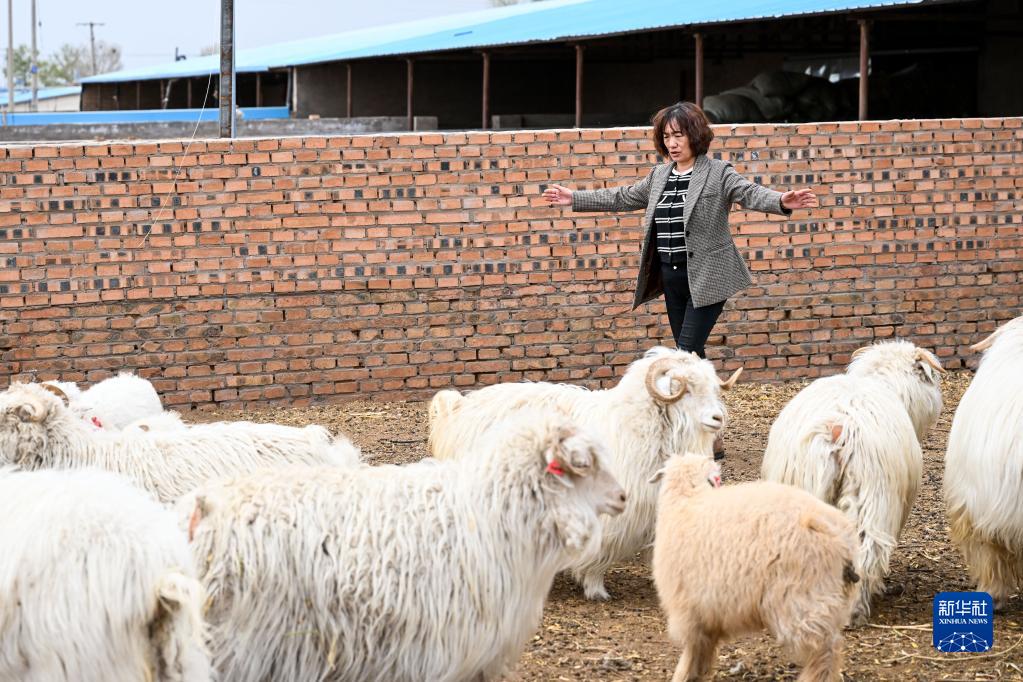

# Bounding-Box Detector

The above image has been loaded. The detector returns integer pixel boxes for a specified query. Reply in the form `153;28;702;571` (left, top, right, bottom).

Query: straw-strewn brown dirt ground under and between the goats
197;372;1023;682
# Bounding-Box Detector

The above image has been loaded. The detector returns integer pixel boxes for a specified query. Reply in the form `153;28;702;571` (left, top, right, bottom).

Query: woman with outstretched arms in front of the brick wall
543;102;817;458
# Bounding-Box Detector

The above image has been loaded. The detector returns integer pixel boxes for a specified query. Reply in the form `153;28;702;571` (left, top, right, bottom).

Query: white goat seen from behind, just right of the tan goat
761;342;941;623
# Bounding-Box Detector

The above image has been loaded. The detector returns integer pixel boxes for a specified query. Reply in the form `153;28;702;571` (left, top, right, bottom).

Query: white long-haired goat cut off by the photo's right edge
944;317;1023;607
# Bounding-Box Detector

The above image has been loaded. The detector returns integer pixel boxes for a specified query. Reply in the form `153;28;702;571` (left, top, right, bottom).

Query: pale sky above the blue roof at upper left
0;0;493;69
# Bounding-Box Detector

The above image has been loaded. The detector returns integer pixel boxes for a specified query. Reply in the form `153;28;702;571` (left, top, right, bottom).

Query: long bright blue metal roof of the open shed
82;0;941;83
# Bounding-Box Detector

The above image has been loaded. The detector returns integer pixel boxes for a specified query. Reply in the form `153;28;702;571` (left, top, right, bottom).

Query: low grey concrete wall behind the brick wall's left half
0;116;437;142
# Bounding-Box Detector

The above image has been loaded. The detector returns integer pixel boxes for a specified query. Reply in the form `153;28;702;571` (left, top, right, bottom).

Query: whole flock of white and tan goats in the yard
0;317;1023;682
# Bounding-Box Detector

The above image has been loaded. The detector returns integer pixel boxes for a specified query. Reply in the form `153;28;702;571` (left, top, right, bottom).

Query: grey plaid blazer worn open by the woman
572;155;792;310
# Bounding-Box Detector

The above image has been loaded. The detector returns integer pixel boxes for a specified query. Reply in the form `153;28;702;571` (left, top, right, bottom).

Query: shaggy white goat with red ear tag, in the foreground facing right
186;415;625;682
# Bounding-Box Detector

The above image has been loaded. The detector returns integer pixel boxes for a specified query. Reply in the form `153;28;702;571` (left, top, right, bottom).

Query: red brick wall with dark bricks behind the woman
0;119;1023;406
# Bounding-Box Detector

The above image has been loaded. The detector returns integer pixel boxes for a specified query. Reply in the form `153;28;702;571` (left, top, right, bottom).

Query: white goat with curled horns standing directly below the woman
430;348;742;599
